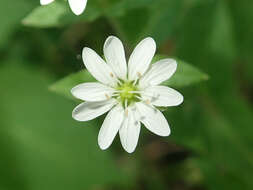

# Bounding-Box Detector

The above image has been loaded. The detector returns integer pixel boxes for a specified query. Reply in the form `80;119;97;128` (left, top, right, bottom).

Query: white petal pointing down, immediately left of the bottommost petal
98;105;124;150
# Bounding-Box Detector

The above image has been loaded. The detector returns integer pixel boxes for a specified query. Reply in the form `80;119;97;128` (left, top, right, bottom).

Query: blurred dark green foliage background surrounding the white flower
0;0;253;190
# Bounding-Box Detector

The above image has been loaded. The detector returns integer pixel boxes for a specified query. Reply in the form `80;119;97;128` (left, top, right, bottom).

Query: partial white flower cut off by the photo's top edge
40;0;87;15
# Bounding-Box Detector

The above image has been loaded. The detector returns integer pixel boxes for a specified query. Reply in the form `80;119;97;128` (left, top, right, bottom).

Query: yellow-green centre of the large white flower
116;81;139;107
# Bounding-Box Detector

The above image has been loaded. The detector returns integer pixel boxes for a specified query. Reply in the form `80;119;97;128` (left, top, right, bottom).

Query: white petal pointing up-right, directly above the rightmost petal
139;59;177;88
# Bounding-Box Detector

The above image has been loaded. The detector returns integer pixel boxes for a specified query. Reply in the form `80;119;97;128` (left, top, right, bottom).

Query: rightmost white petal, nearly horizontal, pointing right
142;86;184;107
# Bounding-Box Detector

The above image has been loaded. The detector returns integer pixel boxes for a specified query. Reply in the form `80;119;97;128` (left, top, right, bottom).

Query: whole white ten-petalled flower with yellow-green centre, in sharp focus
71;36;183;153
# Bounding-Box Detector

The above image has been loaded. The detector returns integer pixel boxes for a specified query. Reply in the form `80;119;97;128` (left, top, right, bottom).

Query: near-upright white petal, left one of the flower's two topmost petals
104;36;127;80
